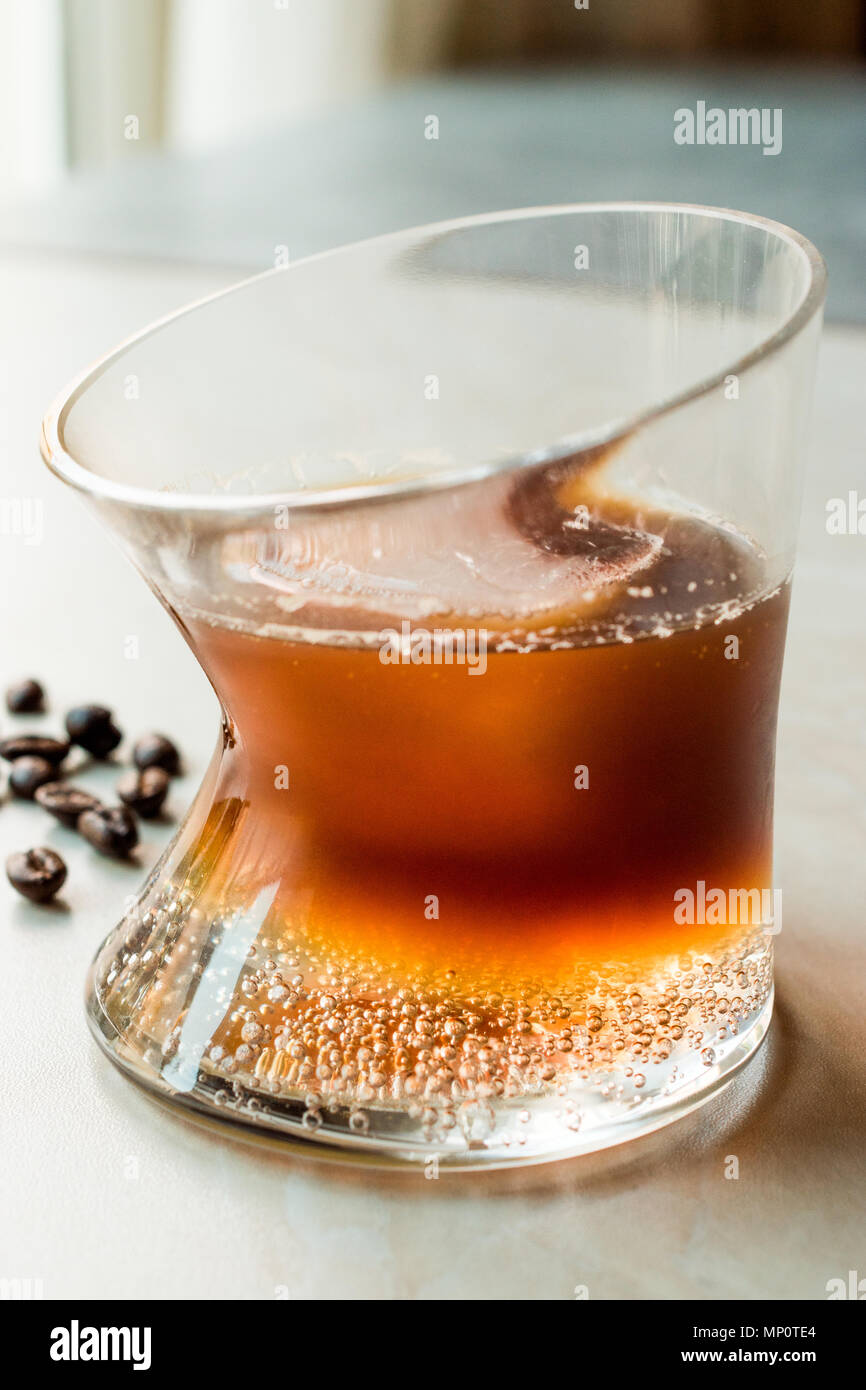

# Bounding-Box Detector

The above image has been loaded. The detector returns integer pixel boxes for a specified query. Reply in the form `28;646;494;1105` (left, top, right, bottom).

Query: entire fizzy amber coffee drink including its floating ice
99;452;788;1147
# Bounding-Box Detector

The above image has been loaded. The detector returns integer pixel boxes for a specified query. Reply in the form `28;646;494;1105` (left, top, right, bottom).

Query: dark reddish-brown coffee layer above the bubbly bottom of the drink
189;521;788;967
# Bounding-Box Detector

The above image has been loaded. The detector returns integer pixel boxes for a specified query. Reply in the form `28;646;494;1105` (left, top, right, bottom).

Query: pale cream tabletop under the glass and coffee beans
0;252;866;1300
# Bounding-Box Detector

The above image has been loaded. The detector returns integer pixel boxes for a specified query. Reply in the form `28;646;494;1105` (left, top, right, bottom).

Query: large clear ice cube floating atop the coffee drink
232;450;662;628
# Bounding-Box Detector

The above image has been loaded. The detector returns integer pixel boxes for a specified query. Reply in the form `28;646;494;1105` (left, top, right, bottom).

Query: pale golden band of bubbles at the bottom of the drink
97;891;771;1148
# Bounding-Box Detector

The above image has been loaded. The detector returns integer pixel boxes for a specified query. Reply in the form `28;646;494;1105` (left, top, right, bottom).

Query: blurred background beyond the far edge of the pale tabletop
0;0;866;321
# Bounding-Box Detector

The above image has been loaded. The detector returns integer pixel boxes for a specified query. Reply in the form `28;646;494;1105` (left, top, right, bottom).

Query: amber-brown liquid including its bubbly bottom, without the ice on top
130;489;788;1123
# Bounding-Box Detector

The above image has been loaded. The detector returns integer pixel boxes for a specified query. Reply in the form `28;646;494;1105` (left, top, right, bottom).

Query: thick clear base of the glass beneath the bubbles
86;962;773;1176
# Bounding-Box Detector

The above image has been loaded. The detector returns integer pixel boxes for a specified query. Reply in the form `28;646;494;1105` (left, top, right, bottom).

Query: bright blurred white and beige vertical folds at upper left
0;0;464;184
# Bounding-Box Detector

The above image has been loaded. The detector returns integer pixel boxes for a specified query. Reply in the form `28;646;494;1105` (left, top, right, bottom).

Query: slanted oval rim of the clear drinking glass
40;200;827;517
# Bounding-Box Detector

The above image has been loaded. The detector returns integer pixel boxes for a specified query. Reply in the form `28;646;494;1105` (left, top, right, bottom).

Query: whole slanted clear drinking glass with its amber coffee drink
43;203;824;1168
